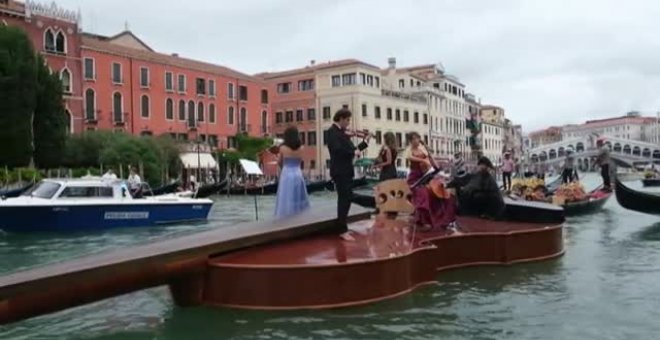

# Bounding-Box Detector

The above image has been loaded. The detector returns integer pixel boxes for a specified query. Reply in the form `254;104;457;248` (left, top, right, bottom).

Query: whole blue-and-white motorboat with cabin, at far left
0;178;213;232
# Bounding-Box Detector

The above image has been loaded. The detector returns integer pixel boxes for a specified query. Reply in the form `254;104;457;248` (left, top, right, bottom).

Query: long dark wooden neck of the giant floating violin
0;204;369;324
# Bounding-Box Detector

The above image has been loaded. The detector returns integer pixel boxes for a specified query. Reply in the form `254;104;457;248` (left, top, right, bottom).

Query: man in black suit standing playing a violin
326;109;369;236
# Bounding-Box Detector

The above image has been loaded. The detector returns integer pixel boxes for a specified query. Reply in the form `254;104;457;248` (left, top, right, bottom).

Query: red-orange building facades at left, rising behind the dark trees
0;0;271;148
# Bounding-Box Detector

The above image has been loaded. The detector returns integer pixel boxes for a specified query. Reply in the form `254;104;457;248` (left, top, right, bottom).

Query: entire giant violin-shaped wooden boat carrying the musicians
0;180;564;324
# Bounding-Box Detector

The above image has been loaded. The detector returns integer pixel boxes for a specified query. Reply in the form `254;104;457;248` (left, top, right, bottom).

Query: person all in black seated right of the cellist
459;157;504;219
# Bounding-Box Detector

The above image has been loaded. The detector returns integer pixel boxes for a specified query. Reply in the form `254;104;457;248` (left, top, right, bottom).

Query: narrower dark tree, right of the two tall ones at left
33;56;69;168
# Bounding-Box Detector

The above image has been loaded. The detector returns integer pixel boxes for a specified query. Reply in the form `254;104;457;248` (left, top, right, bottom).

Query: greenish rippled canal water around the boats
0;176;660;339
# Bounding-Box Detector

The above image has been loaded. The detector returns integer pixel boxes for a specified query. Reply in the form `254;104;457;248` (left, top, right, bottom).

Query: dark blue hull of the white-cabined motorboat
0;203;212;232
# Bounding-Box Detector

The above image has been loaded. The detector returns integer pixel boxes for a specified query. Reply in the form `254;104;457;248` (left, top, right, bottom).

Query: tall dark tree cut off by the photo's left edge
0;25;37;167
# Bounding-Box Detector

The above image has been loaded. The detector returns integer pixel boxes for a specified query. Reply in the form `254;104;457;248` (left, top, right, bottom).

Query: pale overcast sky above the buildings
50;0;660;131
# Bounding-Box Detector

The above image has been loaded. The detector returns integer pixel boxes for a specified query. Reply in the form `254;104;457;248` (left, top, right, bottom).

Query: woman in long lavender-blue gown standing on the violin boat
275;127;309;218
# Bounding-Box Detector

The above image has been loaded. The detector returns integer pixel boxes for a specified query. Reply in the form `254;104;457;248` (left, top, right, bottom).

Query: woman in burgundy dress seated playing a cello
405;132;456;230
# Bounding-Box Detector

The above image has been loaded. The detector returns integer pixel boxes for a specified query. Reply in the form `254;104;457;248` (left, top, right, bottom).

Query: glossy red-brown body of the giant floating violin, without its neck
202;216;564;309
